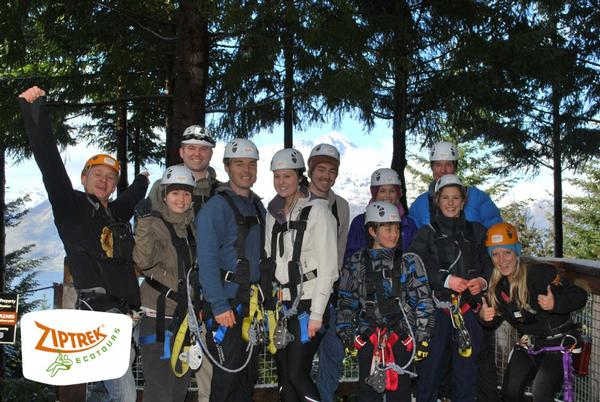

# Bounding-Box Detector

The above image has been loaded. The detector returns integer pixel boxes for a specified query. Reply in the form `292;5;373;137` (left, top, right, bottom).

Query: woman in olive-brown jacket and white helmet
133;165;197;402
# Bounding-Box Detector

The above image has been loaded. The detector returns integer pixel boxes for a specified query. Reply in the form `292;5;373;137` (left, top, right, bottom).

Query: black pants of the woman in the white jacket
275;300;325;402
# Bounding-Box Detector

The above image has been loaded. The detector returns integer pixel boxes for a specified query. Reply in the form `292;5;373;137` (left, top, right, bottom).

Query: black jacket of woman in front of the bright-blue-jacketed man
409;212;493;300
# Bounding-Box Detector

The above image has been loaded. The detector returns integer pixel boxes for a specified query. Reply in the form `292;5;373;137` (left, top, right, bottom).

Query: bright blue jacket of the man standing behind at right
408;184;502;229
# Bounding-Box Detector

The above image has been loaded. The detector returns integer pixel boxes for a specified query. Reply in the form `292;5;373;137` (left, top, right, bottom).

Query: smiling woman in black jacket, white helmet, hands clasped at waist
410;175;492;401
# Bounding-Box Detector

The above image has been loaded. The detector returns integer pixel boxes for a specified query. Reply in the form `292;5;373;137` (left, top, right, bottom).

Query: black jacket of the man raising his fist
19;97;148;310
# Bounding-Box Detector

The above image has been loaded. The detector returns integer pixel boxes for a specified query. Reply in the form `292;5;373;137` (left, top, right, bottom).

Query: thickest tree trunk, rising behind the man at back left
167;0;209;165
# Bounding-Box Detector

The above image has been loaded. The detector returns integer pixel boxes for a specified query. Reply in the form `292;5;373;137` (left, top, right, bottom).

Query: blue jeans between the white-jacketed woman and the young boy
317;307;344;402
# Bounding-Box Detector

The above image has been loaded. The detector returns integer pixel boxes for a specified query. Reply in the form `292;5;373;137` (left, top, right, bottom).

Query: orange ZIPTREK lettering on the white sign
35;321;106;354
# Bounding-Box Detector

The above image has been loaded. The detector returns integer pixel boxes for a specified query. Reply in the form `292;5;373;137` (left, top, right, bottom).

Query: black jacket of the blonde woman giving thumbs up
484;257;588;336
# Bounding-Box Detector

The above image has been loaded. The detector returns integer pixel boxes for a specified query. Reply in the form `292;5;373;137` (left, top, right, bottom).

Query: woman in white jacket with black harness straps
265;148;338;402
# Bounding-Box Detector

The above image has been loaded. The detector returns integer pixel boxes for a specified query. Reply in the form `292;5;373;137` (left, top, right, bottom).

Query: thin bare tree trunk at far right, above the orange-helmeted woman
552;85;563;258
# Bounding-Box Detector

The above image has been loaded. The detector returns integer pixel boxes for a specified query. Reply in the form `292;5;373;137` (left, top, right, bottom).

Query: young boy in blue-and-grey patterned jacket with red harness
337;201;434;402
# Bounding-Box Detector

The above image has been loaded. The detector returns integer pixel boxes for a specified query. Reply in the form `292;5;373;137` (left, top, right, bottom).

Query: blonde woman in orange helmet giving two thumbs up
479;222;588;401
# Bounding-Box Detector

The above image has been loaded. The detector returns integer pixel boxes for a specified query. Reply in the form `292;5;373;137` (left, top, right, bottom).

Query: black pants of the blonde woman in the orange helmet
502;347;563;402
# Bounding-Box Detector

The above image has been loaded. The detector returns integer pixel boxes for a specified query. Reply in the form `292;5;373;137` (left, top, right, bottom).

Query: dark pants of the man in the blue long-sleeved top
206;311;258;402
